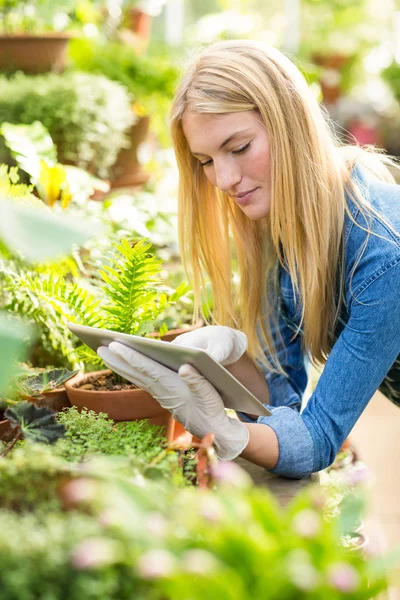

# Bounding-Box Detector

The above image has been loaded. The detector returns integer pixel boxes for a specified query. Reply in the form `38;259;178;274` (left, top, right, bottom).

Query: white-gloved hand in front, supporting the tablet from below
97;342;249;460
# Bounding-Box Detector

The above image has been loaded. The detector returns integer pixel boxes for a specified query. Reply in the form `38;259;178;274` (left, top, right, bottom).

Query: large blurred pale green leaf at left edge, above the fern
0;198;98;262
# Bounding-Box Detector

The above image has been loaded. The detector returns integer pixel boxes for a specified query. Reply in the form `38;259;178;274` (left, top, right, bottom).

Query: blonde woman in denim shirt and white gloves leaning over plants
99;41;400;478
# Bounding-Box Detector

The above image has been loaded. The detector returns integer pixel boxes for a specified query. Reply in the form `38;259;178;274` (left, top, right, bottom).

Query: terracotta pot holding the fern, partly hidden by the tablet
65;370;185;442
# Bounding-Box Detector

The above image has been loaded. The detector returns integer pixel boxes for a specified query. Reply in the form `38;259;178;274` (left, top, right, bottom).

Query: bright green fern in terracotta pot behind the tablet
64;240;186;440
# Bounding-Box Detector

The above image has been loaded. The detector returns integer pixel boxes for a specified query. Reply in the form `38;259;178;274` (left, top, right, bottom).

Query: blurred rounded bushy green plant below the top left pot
0;72;134;176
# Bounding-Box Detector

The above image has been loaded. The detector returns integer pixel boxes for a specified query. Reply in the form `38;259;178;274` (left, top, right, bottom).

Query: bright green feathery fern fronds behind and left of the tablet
3;240;186;368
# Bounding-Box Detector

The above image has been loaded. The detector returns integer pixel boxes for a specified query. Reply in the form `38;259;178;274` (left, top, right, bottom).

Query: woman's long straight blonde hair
171;40;393;372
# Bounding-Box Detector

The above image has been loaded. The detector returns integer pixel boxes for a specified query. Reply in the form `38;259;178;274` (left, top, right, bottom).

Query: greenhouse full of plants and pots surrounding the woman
0;0;400;600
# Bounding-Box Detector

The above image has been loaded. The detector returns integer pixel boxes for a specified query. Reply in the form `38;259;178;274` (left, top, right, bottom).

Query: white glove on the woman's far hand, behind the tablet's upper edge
171;325;247;366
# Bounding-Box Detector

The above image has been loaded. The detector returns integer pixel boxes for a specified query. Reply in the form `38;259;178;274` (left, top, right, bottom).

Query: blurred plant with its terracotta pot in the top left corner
0;0;73;73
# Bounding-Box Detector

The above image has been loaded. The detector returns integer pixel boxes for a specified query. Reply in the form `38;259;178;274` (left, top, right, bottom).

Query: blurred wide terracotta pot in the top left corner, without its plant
0;33;72;73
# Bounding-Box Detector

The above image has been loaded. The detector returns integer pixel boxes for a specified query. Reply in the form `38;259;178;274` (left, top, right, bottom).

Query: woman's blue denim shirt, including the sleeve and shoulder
245;169;400;478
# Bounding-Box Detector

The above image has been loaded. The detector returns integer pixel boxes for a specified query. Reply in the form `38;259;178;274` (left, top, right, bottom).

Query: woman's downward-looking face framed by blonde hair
182;110;271;220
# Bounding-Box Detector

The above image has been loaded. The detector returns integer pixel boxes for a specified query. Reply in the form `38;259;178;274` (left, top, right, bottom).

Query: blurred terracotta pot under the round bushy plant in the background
111;116;150;188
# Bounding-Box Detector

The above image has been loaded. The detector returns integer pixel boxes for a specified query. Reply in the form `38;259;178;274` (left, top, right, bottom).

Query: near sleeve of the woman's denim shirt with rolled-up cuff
257;254;400;478
